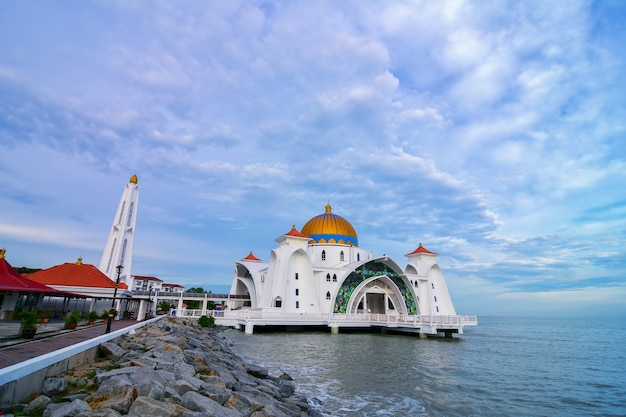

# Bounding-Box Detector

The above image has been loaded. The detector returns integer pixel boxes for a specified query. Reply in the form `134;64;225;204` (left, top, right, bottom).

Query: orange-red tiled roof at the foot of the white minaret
30;263;128;289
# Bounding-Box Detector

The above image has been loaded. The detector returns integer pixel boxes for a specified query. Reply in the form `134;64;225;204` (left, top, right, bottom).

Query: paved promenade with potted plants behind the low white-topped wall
0;320;137;369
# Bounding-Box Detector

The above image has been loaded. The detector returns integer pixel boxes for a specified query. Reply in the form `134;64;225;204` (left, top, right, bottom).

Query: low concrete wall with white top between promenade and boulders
0;316;165;408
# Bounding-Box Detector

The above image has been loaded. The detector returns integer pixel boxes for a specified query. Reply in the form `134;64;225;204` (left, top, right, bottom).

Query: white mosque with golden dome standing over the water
224;203;477;337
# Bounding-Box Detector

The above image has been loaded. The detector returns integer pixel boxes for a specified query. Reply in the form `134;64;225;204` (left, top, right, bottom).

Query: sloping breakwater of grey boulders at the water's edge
16;318;321;417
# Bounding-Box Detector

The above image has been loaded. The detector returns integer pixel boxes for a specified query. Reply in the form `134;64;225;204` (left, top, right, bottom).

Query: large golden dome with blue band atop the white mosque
302;203;359;246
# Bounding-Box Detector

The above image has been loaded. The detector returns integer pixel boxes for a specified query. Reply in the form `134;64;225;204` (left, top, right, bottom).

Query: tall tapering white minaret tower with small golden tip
98;175;139;290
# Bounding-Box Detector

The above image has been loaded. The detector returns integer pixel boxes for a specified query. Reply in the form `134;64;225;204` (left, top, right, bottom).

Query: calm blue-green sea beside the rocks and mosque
225;317;626;416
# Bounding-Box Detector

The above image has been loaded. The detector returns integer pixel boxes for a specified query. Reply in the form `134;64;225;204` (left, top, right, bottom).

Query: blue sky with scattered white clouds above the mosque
0;0;626;316
